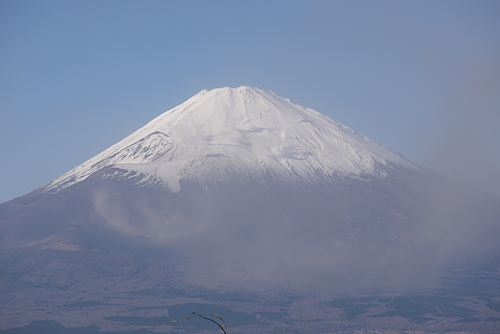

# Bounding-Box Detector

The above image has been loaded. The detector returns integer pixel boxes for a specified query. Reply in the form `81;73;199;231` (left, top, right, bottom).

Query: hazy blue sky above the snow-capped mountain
0;0;500;202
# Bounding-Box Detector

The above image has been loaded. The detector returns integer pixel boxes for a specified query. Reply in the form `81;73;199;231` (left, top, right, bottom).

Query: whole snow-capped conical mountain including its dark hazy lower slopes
0;86;500;333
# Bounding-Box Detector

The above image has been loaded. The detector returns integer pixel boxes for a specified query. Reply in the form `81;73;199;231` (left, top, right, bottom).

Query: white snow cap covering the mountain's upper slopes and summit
41;86;419;192
